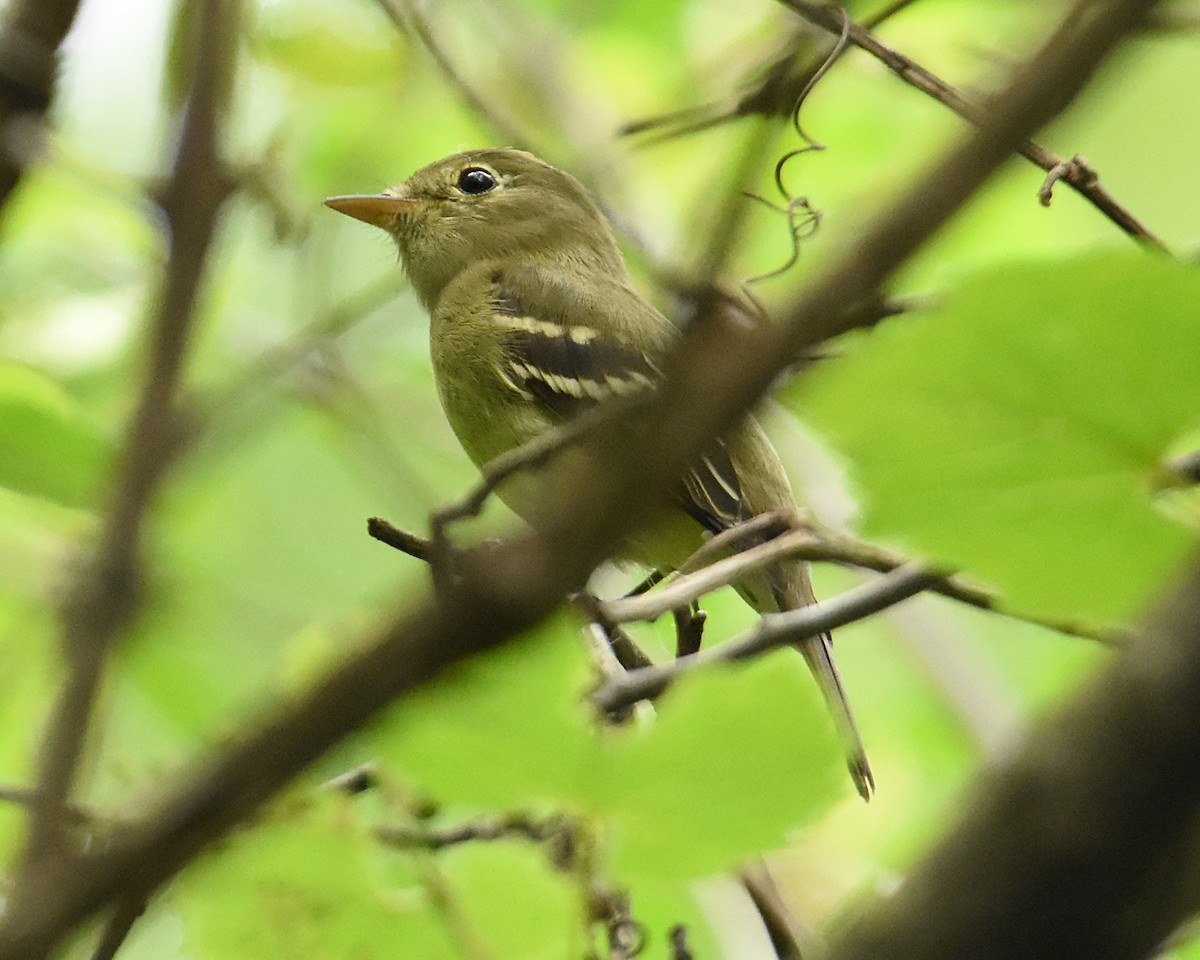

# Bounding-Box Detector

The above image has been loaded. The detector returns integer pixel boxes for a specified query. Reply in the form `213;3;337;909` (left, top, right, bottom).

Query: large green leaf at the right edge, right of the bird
788;253;1200;620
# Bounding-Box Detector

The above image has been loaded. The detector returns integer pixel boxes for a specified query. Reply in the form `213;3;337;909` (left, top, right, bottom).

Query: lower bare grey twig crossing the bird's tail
590;566;932;710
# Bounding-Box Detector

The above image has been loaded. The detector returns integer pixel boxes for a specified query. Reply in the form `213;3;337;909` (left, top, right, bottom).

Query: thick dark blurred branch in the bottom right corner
832;559;1200;960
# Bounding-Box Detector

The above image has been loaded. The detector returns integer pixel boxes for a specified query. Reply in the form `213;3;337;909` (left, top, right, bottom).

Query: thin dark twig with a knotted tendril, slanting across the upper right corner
780;0;1166;252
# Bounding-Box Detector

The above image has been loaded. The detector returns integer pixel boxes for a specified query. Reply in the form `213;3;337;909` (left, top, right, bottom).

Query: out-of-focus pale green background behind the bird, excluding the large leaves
0;0;1200;958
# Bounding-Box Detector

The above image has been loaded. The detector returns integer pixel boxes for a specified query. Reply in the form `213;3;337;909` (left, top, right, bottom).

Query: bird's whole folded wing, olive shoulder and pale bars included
492;266;750;533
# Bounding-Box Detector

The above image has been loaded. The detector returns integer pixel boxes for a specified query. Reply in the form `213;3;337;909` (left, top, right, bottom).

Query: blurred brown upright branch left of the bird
17;0;238;902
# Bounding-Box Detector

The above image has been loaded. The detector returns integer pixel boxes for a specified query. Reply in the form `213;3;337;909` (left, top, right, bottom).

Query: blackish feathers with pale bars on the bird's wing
493;274;749;534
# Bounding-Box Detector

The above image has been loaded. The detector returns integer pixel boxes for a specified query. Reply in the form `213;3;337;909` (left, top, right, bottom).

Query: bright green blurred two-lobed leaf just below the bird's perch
376;619;845;877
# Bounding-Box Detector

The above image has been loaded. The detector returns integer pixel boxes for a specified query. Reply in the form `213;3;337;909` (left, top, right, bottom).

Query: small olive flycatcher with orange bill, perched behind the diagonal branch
324;149;875;799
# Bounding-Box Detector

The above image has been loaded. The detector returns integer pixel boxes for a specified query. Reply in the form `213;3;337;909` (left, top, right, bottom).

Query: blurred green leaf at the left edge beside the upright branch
0;361;108;508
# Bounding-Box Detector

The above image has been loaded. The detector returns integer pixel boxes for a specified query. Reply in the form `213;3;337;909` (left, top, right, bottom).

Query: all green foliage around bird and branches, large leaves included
0;0;1200;960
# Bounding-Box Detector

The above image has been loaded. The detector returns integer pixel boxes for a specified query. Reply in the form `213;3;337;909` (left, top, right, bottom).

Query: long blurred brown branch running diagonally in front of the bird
0;0;1152;960
